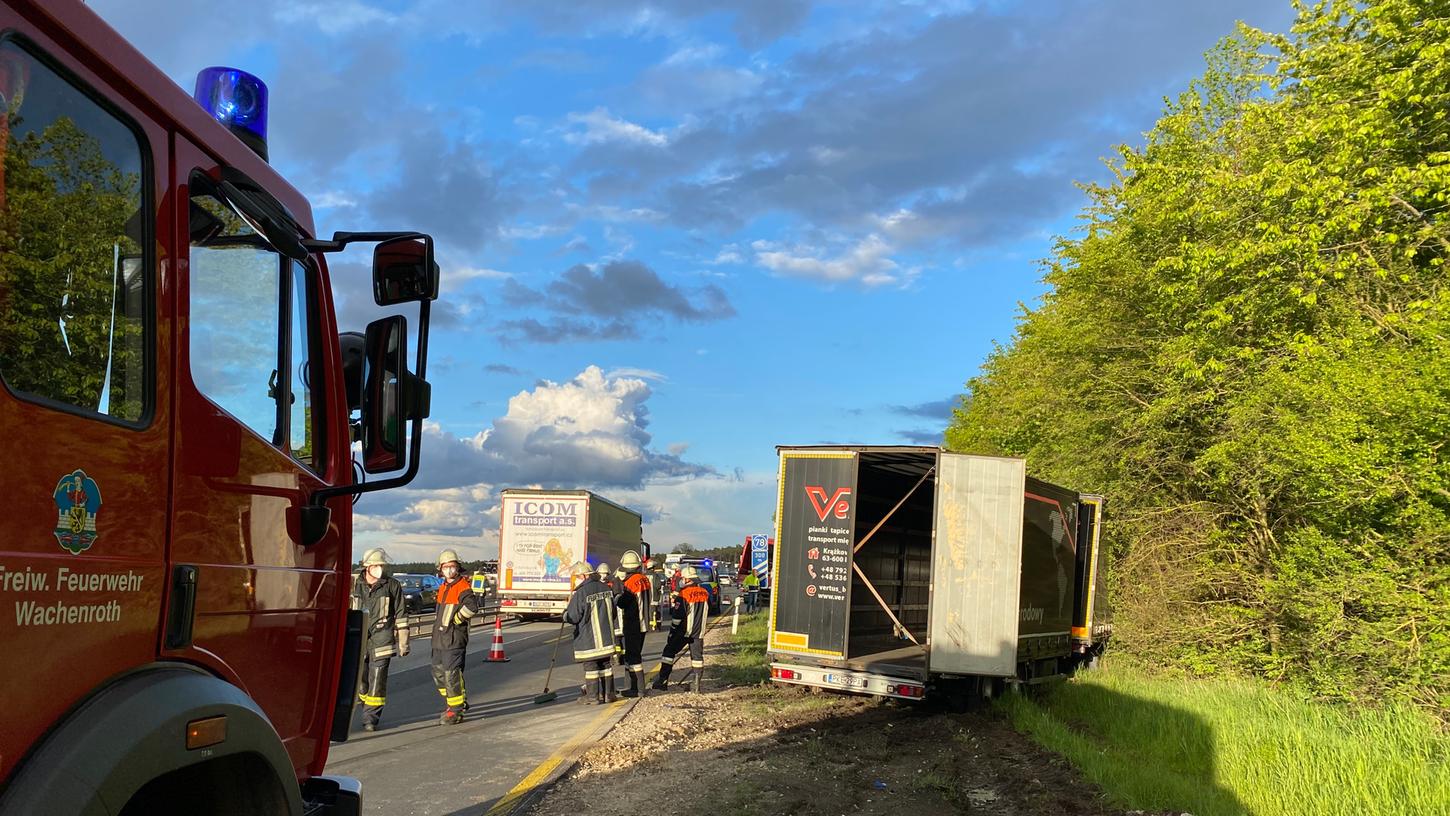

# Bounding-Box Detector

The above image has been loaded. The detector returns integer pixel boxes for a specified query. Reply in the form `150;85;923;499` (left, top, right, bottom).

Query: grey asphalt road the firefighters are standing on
326;622;666;816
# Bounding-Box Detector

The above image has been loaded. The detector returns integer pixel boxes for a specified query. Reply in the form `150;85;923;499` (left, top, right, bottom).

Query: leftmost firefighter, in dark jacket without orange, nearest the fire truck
351;548;407;730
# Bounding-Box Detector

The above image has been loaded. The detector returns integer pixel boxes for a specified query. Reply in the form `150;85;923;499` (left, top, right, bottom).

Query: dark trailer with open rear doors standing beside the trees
769;446;1112;699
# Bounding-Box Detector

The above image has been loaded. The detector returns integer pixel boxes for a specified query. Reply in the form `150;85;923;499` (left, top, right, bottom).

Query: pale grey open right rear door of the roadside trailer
928;452;1027;677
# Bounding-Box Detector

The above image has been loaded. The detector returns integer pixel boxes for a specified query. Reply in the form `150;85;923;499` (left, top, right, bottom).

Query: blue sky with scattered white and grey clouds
91;0;1292;559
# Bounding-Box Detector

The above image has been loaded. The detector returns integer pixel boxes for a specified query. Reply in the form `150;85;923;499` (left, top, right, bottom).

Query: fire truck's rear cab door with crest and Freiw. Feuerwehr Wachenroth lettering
0;27;174;780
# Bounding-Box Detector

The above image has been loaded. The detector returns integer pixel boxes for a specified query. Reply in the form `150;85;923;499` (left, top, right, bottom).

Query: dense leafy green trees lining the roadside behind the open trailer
947;0;1450;710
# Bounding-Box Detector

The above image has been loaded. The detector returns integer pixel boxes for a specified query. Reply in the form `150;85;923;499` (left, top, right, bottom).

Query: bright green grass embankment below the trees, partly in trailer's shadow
1002;667;1450;816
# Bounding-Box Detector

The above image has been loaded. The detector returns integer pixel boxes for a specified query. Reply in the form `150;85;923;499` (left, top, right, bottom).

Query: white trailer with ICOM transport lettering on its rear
497;488;650;617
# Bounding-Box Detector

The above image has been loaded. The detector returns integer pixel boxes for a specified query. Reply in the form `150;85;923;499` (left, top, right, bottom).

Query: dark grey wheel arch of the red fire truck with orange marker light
0;664;302;816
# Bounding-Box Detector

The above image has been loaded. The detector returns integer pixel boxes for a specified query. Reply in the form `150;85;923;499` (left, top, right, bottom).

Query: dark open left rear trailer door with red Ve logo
770;451;857;658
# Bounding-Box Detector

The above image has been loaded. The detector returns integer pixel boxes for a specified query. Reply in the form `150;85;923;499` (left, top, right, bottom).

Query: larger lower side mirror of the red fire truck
363;315;412;472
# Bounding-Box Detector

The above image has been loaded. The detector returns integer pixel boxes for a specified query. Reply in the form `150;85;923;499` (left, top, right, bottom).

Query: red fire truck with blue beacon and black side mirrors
0;0;438;815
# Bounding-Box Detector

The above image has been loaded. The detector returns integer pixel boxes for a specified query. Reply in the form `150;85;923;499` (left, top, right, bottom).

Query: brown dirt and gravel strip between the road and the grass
529;628;1122;816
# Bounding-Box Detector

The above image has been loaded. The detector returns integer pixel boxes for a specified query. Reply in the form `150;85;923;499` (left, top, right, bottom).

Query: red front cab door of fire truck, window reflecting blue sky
168;138;345;767
